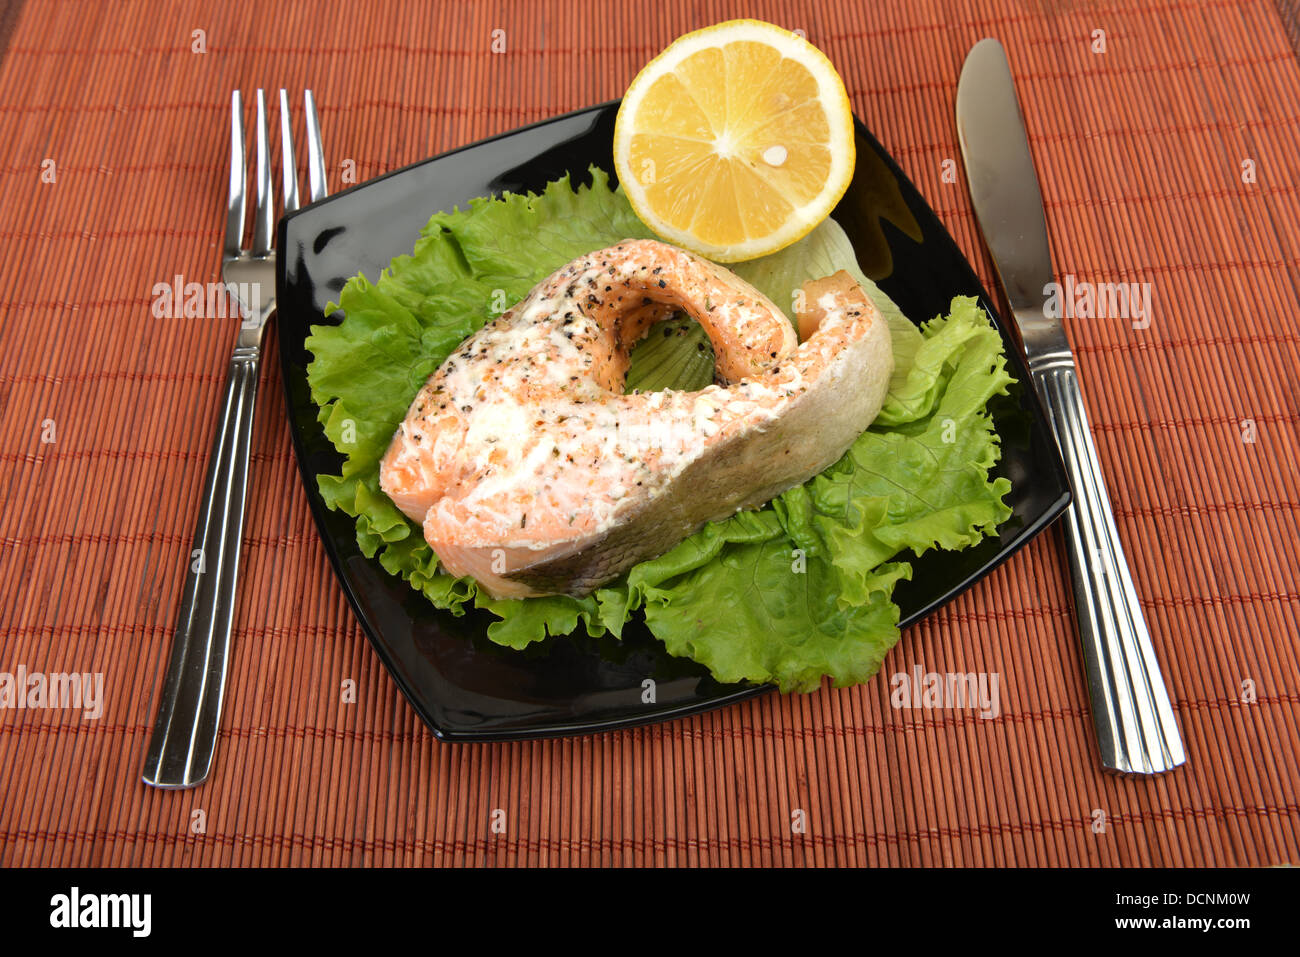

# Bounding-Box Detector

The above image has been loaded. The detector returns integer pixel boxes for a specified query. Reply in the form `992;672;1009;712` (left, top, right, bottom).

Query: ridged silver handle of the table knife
1031;354;1186;774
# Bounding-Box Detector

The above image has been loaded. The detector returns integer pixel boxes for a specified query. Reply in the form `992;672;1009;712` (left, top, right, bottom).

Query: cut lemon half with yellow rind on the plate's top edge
614;20;855;263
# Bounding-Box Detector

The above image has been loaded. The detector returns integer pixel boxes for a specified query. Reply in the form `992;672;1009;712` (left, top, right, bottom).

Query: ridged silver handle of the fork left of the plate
144;345;261;788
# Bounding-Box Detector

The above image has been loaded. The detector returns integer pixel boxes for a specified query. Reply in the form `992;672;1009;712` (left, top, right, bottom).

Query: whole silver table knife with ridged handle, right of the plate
957;39;1186;774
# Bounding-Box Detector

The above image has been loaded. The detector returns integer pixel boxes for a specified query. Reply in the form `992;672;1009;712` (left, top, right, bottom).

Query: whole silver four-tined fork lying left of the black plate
144;90;326;788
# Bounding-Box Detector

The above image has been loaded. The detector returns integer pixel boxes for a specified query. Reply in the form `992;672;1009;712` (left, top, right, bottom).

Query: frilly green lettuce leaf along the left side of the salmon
306;166;651;634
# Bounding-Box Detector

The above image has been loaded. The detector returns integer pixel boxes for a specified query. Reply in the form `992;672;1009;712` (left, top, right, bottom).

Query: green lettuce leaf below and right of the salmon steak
598;299;1011;690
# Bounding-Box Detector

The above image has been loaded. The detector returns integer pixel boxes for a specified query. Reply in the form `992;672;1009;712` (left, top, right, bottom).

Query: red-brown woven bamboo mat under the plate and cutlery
0;0;1300;865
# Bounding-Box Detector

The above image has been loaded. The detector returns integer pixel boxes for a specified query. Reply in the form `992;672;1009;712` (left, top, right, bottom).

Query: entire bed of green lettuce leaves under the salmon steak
307;168;1011;690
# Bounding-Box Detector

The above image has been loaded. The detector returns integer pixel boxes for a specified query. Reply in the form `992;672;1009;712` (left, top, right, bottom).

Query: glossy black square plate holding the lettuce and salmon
276;103;1069;741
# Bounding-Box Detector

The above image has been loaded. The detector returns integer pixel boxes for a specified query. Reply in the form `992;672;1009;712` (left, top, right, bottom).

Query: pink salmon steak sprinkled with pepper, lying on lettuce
380;239;893;598
